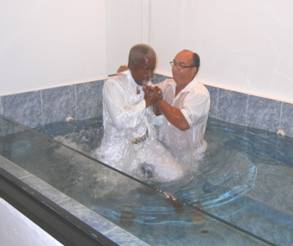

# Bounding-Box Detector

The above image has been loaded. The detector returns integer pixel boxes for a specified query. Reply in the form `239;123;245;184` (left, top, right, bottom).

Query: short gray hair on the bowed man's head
128;44;156;68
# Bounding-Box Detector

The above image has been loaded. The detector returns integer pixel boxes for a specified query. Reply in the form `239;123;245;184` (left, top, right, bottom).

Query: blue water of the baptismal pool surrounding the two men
0;116;293;245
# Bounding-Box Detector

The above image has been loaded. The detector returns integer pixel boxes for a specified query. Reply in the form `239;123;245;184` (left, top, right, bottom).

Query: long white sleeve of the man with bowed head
103;80;146;129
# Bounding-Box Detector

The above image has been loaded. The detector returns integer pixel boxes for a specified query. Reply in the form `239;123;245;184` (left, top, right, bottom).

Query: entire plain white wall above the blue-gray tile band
0;0;293;102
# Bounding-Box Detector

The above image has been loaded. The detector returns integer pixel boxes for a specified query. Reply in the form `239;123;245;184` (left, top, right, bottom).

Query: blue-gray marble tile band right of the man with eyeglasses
207;86;293;137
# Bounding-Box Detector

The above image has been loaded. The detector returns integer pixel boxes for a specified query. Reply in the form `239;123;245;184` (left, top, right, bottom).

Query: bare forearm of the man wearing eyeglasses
157;99;189;130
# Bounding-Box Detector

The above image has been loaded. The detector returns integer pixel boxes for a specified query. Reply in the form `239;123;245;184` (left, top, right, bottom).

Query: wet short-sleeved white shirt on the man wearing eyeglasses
158;78;210;163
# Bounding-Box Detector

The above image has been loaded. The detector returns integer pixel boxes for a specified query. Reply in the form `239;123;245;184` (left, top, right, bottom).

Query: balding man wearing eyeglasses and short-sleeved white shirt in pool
151;50;210;163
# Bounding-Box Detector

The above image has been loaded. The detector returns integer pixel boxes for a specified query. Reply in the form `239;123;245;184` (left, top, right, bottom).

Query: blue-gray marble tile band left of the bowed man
0;80;104;128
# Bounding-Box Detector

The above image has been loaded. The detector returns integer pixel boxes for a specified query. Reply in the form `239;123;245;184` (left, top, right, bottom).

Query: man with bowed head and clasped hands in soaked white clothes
96;44;183;182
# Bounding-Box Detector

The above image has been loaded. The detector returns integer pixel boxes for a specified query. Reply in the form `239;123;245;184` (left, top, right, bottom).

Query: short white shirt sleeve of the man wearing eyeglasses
181;87;210;126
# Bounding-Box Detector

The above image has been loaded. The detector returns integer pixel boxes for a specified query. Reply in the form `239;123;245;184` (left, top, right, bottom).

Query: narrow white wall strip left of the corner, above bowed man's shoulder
106;0;150;74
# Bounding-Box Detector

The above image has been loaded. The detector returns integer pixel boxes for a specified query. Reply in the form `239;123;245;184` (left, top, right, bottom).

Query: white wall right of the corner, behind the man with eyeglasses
150;0;293;102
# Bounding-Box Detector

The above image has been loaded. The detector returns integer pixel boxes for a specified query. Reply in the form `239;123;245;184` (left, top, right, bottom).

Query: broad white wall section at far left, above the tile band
0;0;106;95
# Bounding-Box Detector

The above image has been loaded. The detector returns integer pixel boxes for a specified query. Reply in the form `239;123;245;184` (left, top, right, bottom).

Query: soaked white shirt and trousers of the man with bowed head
96;71;183;181
